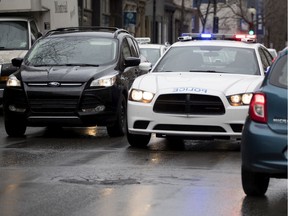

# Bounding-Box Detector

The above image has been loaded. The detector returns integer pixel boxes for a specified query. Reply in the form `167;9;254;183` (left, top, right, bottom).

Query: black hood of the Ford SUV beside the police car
21;66;113;83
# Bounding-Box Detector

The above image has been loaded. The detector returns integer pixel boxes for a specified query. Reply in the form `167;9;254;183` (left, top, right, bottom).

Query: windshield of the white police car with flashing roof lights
152;46;260;75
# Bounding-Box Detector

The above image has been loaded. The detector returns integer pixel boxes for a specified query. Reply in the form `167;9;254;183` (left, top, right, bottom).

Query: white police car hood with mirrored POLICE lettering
132;72;264;95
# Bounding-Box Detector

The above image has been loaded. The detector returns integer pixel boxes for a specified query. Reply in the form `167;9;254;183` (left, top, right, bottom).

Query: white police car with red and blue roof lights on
127;35;272;146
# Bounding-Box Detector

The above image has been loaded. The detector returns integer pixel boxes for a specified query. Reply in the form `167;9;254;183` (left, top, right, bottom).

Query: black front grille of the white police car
153;94;225;115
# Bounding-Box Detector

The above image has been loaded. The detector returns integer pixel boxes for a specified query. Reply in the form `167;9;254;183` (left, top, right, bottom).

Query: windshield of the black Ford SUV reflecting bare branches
25;36;118;66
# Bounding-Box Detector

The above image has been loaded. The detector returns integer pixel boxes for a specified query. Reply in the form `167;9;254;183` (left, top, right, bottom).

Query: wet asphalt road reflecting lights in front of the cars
0;111;287;216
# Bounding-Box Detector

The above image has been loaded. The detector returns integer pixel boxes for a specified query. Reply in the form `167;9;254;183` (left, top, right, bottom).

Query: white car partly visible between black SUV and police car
136;37;169;65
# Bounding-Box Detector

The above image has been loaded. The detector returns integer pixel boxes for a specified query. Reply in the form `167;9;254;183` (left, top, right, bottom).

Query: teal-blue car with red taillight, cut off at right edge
241;49;288;196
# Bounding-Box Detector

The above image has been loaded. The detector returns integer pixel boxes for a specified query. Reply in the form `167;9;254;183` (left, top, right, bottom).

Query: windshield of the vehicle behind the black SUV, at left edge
0;21;29;50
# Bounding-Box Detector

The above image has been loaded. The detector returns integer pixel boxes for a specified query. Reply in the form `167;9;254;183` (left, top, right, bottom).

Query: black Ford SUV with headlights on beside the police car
3;27;149;137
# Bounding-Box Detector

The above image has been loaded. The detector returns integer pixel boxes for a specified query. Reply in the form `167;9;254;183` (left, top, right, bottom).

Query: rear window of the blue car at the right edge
270;55;288;88
